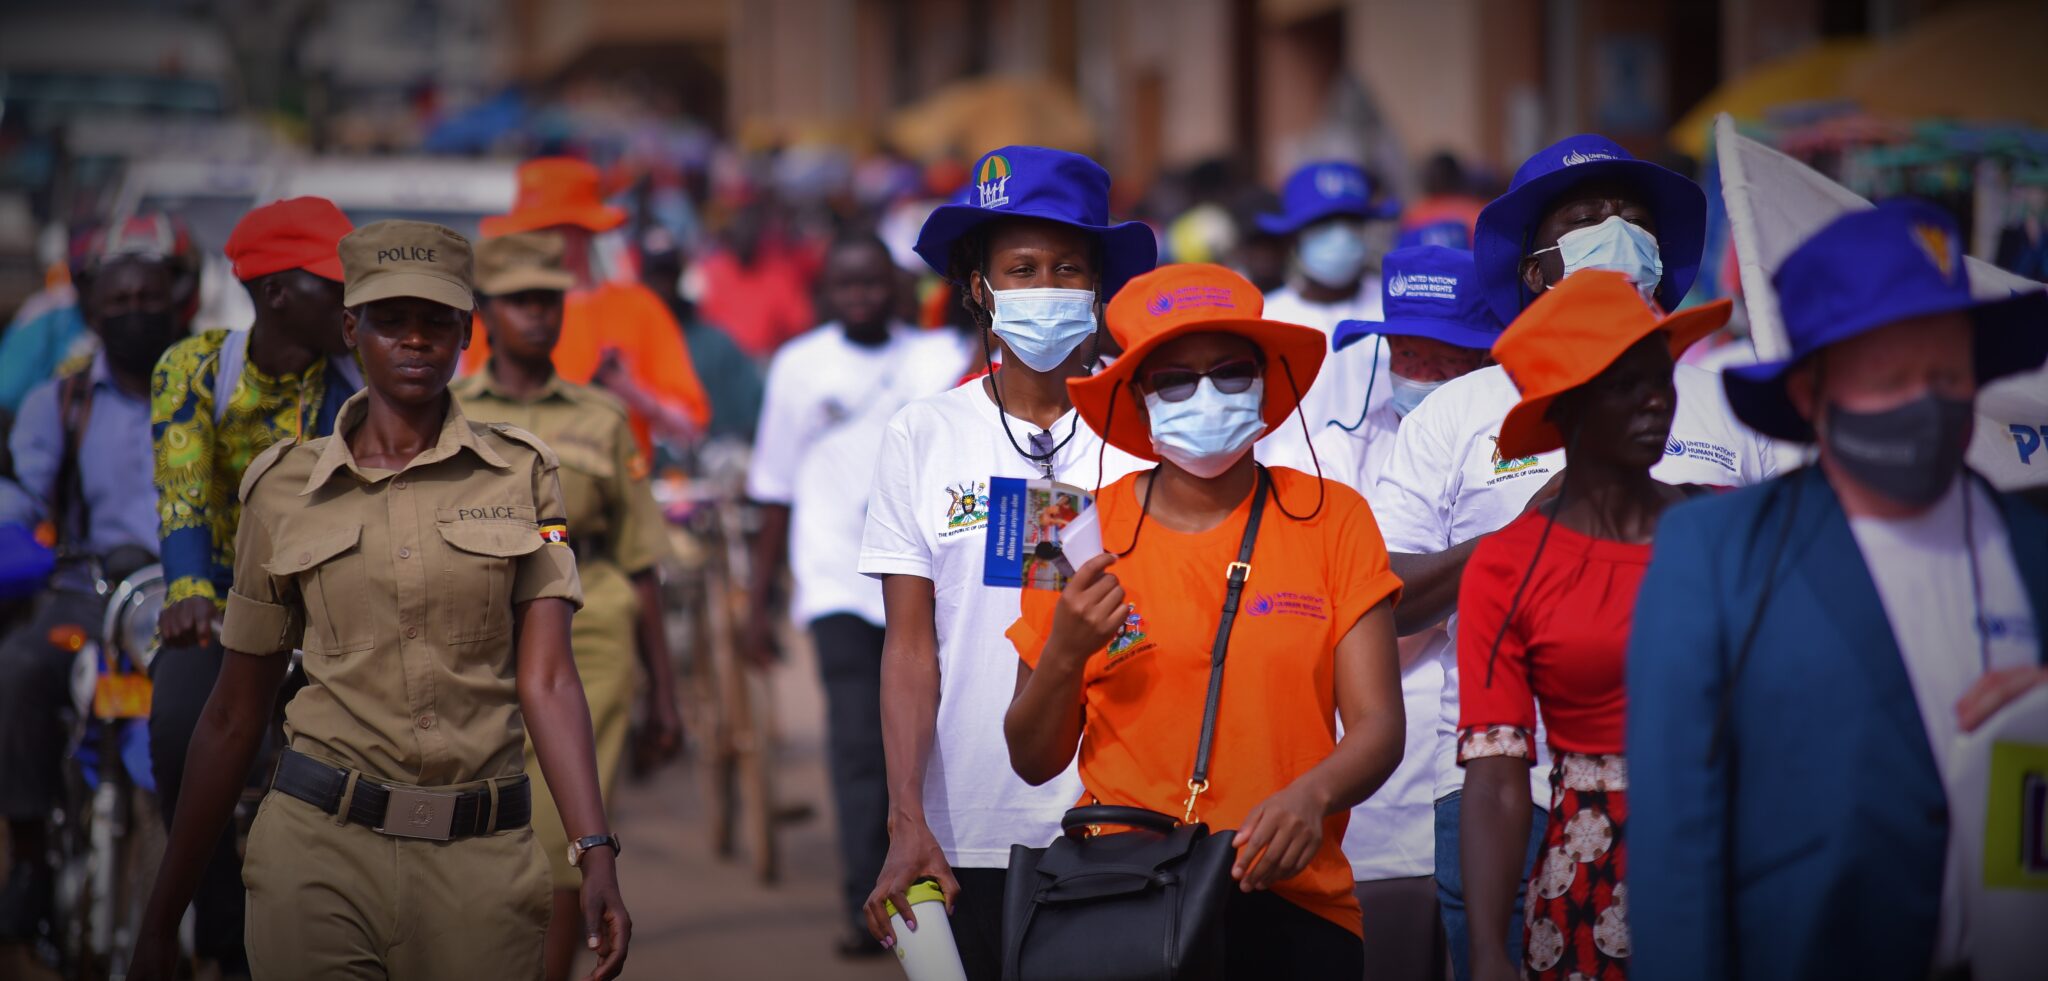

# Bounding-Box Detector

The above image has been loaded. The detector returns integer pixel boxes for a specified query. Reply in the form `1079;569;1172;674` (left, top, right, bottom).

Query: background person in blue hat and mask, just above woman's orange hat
1255;160;1397;473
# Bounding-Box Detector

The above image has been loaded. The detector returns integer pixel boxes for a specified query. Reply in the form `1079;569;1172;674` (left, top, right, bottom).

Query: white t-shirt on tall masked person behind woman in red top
1372;365;1776;807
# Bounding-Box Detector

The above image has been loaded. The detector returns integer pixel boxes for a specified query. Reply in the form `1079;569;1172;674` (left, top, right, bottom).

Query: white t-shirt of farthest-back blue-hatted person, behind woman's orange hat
1253;280;1393;473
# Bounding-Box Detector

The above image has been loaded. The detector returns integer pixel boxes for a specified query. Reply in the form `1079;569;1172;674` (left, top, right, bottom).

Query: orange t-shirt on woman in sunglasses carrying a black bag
1010;467;1401;934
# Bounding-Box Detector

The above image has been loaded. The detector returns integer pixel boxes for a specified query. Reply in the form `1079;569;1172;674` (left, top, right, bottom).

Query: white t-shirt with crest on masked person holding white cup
860;379;1149;868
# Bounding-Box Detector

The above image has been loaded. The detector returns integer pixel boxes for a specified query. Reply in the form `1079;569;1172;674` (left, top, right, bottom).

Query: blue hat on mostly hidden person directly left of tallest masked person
1331;246;1501;350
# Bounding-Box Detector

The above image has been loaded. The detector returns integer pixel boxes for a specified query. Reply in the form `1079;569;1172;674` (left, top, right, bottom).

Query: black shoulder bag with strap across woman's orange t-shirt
1004;467;1268;981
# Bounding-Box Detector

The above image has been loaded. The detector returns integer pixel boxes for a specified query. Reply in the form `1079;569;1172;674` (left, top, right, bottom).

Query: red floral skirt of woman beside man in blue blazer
1522;752;1628;981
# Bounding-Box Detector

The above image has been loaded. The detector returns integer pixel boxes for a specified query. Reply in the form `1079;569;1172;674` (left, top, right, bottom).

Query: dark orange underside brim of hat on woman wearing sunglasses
1067;317;1329;463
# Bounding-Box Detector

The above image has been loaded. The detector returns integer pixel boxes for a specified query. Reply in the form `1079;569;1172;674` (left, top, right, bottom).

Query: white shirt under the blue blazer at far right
1849;477;2040;967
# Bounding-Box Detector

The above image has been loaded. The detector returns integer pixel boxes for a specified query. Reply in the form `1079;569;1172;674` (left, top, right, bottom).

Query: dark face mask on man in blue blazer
1827;393;1974;508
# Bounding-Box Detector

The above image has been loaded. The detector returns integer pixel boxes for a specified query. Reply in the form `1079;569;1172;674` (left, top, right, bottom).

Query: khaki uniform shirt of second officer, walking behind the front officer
449;369;668;588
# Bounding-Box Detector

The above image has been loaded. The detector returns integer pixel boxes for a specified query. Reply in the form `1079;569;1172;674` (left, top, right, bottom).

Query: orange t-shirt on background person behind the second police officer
463;283;711;451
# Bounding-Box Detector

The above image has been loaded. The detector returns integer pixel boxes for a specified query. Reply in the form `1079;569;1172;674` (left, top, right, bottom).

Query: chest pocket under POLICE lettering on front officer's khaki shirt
434;504;541;643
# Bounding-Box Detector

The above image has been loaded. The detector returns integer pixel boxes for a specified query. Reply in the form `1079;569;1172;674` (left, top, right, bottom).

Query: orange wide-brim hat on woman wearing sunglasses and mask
1067;262;1329;463
